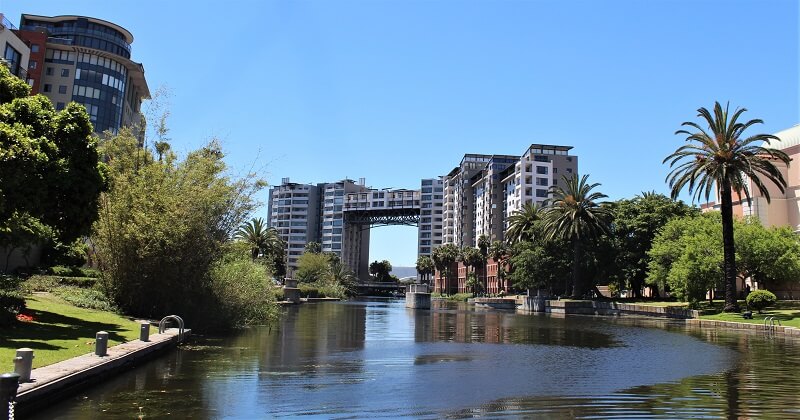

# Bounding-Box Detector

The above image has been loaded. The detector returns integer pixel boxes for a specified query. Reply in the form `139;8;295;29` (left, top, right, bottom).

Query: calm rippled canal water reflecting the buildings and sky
31;301;800;419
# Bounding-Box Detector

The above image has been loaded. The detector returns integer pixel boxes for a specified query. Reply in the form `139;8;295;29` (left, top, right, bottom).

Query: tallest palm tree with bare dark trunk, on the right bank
663;102;790;312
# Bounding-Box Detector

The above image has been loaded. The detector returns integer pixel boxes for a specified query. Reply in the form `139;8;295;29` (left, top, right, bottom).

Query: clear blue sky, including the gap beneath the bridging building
0;0;800;266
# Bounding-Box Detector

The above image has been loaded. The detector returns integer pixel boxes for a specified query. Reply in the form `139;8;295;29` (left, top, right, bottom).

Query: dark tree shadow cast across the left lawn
0;310;126;350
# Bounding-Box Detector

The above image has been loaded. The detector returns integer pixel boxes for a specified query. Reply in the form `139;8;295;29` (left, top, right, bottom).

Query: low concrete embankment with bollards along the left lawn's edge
16;328;191;414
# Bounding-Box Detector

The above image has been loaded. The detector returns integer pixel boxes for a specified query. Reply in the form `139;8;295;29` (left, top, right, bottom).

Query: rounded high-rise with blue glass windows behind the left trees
13;14;150;133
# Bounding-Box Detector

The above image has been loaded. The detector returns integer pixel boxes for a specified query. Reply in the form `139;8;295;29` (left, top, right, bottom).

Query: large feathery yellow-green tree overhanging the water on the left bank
92;129;264;326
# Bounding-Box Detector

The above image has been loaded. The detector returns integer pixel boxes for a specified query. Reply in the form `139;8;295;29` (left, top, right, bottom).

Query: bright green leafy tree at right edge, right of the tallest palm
735;217;800;289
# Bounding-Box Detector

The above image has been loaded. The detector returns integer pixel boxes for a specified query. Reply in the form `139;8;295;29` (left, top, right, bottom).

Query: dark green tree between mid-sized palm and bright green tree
602;192;698;297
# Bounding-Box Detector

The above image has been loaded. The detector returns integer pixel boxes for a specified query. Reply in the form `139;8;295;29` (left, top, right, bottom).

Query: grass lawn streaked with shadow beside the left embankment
0;293;139;372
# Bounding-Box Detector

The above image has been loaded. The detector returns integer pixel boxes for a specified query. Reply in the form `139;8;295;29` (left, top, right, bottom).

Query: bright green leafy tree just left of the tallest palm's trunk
647;213;723;303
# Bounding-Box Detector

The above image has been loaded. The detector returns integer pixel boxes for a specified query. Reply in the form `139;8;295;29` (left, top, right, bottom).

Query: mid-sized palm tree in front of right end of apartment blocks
543;174;611;298
